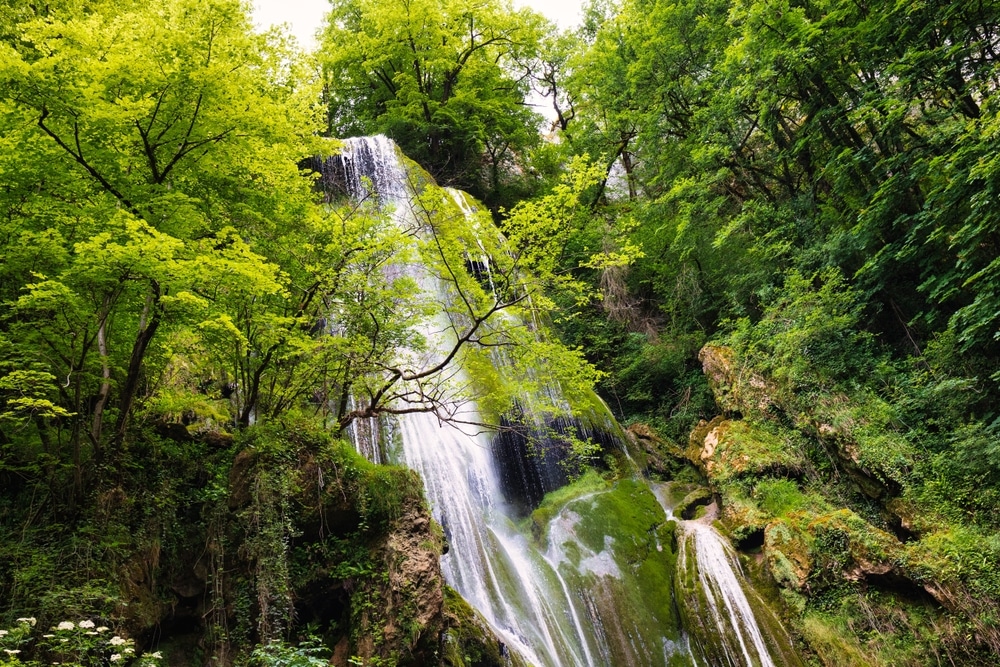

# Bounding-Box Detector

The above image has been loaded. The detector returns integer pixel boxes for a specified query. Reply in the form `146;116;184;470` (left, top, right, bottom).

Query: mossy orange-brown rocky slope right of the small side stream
685;336;1000;665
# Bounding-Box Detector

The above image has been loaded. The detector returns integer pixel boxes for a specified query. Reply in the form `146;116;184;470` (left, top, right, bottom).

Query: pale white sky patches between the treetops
253;0;582;49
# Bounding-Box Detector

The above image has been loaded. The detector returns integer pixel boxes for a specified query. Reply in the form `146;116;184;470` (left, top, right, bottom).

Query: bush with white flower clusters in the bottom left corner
0;618;162;667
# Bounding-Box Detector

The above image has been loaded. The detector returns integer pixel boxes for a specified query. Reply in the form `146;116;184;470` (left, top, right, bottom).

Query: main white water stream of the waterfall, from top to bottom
328;137;605;667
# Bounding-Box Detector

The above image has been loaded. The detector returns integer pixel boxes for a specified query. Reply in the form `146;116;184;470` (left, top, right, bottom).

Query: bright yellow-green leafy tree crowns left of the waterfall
0;0;317;473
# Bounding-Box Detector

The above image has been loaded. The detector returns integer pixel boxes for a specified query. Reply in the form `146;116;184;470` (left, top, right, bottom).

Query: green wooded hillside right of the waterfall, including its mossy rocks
528;0;1000;664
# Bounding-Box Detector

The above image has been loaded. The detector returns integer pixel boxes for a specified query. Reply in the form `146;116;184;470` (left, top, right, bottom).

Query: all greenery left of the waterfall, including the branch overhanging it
0;0;595;664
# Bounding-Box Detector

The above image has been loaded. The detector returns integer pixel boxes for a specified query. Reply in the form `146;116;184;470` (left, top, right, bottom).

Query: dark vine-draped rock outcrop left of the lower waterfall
188;447;446;667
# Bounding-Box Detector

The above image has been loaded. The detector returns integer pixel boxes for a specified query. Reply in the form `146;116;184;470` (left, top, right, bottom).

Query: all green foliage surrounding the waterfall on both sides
0;0;1000;664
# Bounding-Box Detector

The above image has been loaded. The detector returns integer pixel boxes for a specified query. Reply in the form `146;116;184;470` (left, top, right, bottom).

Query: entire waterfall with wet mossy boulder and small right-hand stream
322;137;800;667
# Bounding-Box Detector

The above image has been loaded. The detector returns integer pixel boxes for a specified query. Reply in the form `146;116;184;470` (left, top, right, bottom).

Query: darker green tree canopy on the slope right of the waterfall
567;0;1000;370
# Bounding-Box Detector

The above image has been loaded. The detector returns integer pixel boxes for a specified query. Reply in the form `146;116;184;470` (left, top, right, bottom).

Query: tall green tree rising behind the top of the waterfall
321;0;545;208
